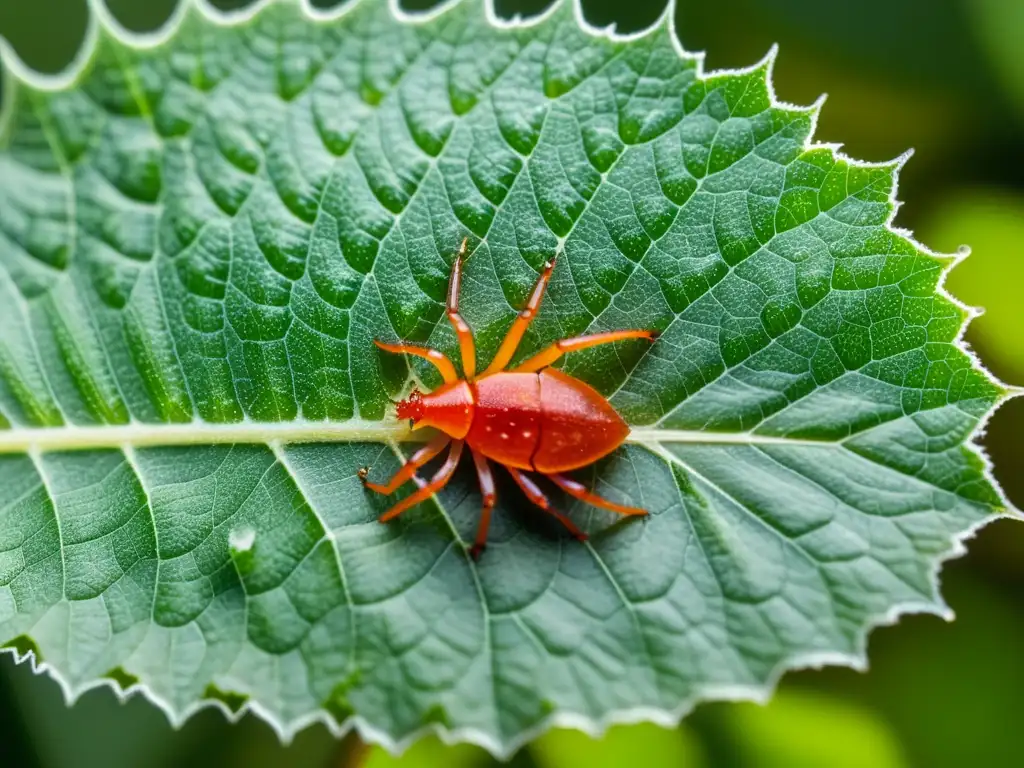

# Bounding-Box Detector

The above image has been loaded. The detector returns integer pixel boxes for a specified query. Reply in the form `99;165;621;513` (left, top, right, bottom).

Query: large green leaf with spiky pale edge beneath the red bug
0;0;1006;754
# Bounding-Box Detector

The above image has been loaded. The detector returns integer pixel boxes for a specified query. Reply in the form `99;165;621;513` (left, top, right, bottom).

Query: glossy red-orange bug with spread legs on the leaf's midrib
359;241;656;559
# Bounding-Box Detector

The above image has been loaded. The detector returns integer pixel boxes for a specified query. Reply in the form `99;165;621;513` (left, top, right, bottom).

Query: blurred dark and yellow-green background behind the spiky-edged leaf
0;0;1024;768
